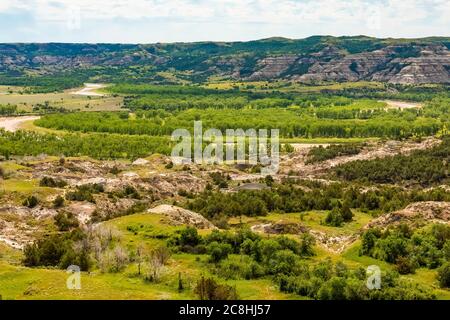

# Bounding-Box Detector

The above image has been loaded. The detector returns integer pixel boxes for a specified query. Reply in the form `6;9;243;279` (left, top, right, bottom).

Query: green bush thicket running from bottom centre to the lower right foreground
173;228;438;300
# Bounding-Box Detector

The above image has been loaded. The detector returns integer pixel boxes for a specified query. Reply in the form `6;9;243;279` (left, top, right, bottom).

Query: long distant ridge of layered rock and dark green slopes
0;37;450;84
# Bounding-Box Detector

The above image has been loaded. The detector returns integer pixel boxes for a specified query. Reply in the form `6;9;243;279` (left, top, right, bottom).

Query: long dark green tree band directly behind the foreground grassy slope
186;181;450;220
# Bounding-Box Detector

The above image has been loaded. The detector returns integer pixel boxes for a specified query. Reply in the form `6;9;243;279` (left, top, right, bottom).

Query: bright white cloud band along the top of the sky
0;0;450;23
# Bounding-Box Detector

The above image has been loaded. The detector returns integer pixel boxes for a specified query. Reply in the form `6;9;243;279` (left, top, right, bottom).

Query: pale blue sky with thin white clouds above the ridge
0;0;450;43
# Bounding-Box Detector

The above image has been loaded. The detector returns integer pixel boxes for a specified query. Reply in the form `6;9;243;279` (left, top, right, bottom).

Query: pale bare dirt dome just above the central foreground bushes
148;204;217;229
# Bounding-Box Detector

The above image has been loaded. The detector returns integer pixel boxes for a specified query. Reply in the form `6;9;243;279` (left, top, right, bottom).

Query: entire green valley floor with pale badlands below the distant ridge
0;80;450;300
